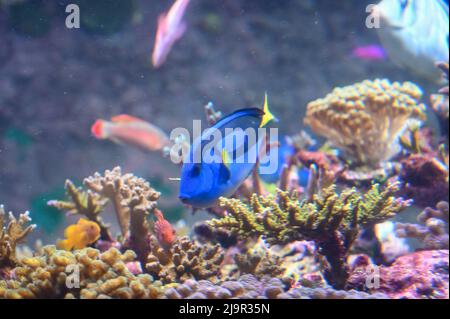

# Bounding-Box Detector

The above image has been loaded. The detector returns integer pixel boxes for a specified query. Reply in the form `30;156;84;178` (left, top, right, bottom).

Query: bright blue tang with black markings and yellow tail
179;95;275;208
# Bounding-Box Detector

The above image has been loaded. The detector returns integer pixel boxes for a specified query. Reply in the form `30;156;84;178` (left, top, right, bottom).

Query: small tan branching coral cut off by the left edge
0;206;36;269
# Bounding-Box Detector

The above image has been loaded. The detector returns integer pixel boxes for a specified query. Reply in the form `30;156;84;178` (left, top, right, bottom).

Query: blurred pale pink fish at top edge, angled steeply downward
152;0;190;68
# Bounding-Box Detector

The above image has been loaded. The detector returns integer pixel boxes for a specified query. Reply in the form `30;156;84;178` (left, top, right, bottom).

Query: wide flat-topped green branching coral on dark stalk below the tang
209;184;409;288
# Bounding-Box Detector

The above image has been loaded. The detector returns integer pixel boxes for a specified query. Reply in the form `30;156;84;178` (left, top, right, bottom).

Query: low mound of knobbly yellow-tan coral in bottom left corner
0;246;162;299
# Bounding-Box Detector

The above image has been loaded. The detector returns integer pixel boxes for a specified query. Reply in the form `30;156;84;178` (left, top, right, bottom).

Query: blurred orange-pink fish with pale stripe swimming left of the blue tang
91;114;171;151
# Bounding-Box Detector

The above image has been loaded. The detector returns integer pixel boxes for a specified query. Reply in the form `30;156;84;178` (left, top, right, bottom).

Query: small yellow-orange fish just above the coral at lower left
58;218;100;250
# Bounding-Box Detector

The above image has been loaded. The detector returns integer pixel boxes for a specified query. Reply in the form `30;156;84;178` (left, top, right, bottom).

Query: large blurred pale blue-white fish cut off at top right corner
372;0;449;82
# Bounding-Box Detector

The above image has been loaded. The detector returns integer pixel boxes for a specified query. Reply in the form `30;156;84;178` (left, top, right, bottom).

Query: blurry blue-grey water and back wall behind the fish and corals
0;0;448;298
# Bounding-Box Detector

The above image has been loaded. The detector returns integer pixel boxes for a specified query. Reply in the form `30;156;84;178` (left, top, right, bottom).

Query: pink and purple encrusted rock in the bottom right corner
347;250;449;299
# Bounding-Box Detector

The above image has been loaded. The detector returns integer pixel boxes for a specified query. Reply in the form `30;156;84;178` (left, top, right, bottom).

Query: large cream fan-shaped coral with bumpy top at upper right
304;79;425;168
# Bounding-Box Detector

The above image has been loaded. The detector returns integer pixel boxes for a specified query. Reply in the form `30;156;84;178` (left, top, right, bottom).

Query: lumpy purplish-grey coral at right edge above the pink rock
396;202;449;250
